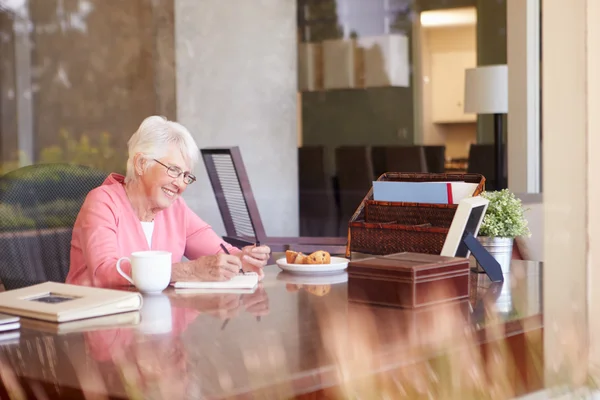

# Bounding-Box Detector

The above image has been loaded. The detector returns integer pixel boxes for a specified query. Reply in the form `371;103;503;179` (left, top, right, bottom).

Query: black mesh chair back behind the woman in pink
0;163;107;290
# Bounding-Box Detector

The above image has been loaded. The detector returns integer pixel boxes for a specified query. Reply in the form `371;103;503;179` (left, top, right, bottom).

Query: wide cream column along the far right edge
542;0;600;386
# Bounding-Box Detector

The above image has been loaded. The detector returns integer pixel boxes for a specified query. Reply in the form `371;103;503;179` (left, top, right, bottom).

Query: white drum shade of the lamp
465;65;508;114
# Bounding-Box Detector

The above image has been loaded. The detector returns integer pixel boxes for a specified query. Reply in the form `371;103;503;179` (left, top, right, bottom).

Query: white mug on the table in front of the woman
117;250;171;293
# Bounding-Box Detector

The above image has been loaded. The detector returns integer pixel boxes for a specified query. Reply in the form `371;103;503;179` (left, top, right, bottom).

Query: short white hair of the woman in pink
125;115;200;182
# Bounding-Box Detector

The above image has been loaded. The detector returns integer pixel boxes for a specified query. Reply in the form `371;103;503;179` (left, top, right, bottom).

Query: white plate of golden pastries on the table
275;250;348;274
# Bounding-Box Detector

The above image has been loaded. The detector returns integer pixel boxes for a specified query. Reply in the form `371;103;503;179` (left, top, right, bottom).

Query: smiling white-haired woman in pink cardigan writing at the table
67;116;270;287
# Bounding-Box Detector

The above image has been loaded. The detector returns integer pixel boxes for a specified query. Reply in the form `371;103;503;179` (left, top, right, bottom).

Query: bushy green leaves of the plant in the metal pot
479;189;531;239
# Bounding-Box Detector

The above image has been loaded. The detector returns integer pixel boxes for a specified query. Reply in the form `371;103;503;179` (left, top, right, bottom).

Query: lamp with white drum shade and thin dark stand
465;65;508;190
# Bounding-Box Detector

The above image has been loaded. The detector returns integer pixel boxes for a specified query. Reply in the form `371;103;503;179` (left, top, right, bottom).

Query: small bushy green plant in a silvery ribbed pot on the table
477;189;531;273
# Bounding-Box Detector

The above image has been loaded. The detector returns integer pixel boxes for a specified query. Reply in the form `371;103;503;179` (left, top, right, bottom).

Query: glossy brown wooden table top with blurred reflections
0;261;543;399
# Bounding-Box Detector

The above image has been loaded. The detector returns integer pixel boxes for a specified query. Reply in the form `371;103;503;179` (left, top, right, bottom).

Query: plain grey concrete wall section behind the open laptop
175;0;298;236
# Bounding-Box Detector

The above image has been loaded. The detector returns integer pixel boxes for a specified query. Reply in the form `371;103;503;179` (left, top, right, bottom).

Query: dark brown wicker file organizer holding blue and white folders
346;172;485;257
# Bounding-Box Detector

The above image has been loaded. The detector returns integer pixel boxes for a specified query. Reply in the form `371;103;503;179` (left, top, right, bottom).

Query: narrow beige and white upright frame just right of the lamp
506;0;541;193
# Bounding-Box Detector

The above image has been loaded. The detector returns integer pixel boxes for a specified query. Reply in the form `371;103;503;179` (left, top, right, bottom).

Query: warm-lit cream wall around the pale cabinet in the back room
421;26;477;158
